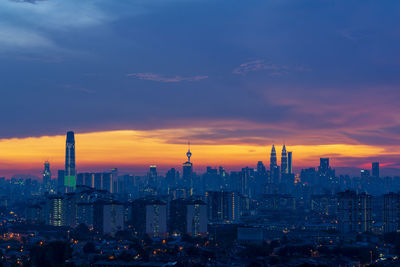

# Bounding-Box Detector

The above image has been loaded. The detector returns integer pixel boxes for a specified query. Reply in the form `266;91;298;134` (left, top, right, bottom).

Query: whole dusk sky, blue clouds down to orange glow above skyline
0;0;400;176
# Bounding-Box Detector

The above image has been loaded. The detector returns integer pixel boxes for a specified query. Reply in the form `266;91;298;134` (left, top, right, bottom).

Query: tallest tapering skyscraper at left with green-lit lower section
64;132;76;192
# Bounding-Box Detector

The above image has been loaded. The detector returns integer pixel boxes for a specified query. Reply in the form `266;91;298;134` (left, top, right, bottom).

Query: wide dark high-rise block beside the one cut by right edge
337;191;372;233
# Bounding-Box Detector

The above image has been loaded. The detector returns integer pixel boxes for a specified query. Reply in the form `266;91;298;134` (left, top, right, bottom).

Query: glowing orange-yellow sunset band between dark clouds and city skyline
0;129;397;178
